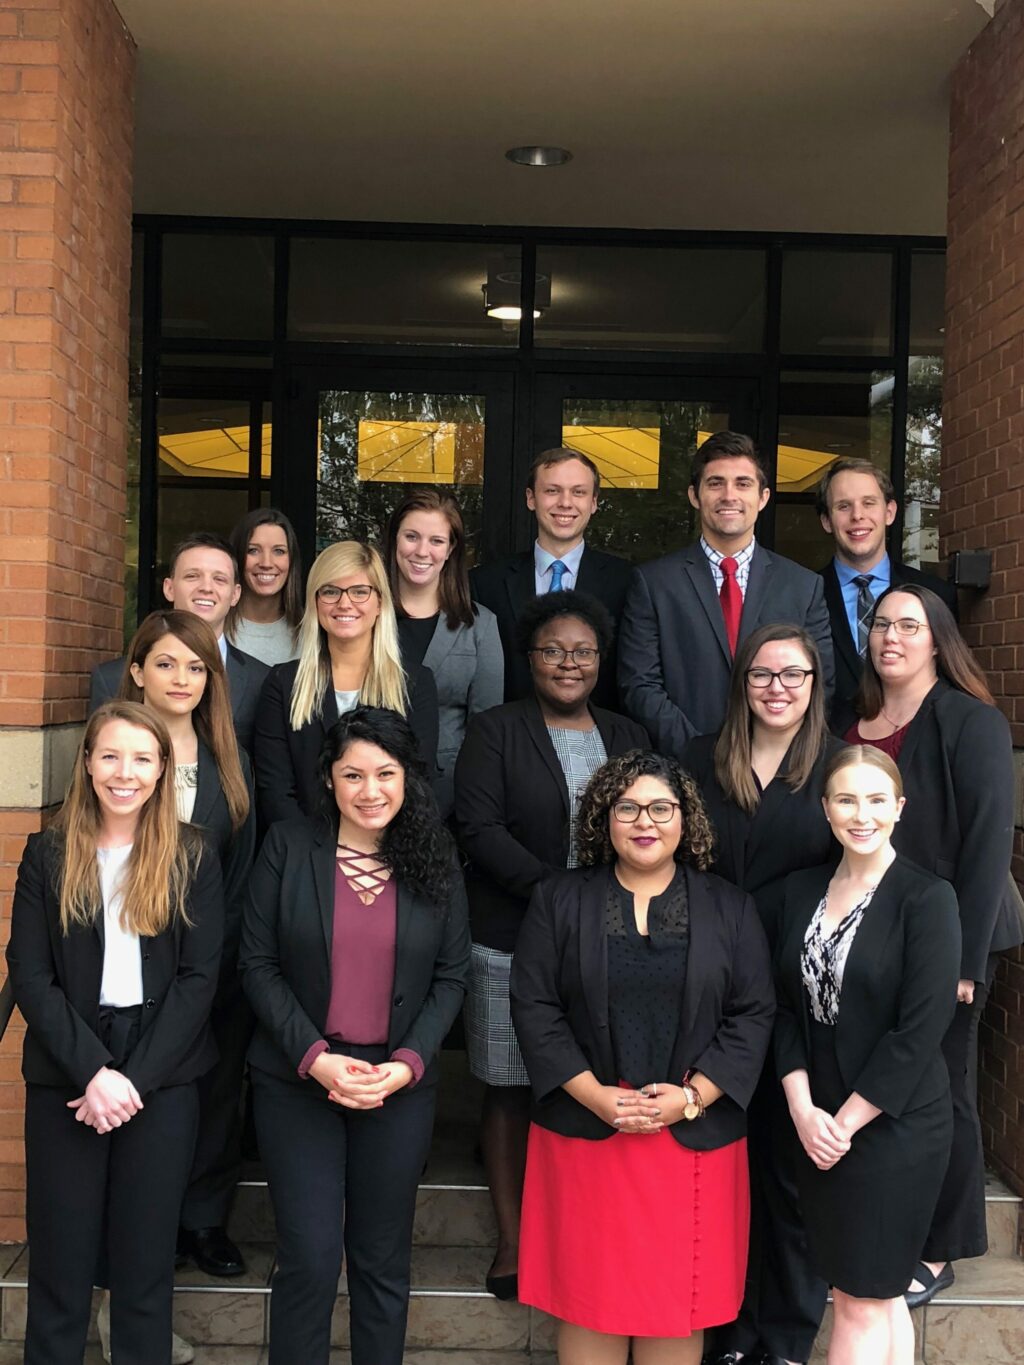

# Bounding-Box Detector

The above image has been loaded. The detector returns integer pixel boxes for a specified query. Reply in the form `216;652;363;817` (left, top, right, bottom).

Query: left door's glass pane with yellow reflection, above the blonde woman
317;389;485;562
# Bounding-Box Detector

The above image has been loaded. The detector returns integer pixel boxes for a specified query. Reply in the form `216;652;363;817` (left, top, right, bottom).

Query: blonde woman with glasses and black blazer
254;541;437;826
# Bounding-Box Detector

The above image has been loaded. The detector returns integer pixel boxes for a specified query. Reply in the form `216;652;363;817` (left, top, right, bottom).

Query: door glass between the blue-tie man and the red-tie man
561;397;729;564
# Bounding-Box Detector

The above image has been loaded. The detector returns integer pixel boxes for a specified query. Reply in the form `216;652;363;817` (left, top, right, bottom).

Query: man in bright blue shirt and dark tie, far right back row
818;459;957;708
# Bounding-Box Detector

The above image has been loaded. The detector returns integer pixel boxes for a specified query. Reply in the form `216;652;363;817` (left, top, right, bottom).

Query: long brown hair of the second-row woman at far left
119;612;248;830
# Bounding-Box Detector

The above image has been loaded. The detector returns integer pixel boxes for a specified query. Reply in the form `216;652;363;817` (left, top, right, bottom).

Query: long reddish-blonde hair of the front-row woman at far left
53;702;202;938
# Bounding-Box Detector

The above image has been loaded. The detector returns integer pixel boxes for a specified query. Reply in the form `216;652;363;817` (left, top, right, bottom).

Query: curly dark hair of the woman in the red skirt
576;749;714;872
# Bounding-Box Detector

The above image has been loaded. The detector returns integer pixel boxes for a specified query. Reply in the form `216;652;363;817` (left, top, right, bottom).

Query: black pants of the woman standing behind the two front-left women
182;979;254;1231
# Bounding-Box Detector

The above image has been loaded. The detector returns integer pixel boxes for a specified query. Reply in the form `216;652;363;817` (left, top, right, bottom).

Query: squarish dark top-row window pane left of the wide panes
161;232;274;341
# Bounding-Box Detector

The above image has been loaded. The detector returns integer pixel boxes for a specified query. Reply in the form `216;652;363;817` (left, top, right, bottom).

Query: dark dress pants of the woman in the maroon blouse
251;1047;436;1365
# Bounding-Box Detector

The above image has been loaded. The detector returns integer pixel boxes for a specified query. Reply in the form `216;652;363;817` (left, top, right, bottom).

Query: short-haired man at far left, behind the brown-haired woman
89;531;269;752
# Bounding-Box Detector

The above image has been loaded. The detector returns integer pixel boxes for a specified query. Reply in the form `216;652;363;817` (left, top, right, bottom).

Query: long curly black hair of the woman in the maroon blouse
318;706;455;913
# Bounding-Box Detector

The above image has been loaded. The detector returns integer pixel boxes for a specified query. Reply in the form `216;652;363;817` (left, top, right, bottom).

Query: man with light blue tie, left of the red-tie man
470;446;631;711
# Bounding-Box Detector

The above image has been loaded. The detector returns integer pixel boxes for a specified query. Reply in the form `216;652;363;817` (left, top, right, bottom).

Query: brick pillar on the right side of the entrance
939;0;1024;1193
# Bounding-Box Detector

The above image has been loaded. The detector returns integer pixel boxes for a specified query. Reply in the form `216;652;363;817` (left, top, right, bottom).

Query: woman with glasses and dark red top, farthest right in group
840;583;1021;1308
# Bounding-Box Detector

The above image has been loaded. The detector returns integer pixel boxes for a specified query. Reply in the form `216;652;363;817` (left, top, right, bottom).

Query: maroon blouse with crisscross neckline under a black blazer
299;867;423;1084
